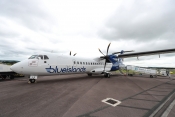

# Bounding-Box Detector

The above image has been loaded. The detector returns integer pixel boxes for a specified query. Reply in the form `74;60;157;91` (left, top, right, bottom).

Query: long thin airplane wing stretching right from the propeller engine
118;49;175;58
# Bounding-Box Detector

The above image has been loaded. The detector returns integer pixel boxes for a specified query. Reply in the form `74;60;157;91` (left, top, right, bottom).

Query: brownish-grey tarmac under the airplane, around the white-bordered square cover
0;74;175;117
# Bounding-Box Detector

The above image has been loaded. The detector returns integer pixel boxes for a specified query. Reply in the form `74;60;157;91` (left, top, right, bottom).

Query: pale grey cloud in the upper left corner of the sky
0;0;54;32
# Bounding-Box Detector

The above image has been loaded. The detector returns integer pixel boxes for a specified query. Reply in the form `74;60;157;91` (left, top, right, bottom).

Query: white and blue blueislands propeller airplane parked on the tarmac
10;43;175;83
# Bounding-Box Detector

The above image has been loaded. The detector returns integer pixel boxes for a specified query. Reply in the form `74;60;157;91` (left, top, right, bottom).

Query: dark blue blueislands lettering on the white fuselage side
45;66;86;73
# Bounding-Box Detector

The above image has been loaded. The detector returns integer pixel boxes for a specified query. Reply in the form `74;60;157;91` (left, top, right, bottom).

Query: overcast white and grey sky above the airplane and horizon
0;0;175;67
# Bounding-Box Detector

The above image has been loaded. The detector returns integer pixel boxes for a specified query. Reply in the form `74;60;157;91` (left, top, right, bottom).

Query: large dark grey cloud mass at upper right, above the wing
98;0;175;42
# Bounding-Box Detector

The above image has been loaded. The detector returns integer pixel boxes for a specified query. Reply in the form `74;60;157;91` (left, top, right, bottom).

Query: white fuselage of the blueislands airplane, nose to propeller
11;54;112;76
